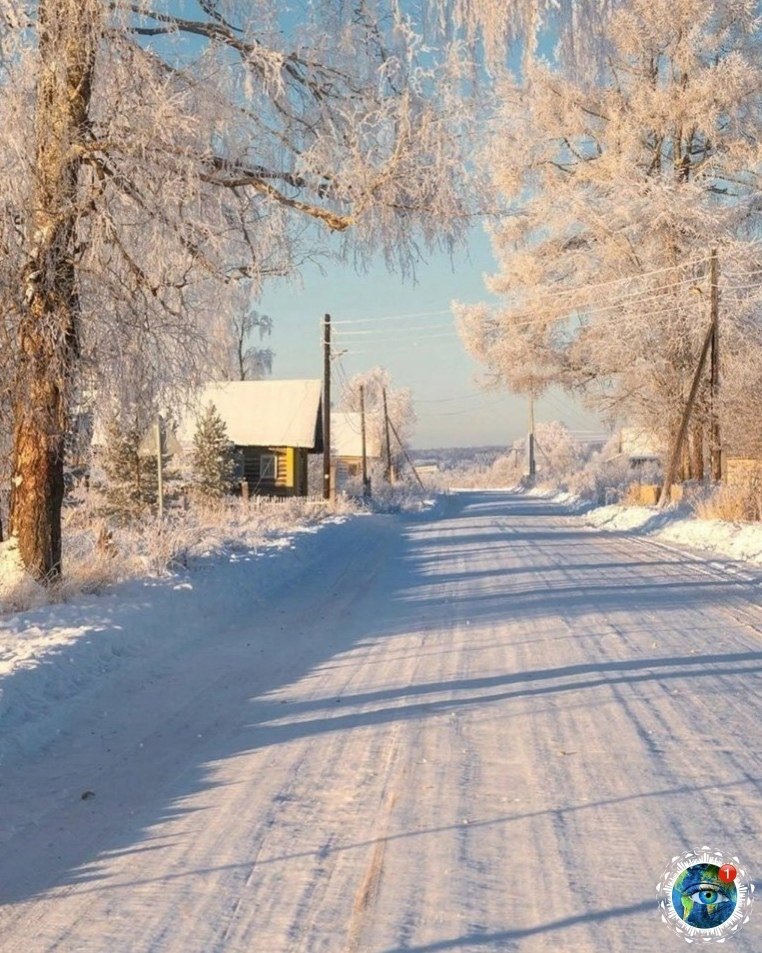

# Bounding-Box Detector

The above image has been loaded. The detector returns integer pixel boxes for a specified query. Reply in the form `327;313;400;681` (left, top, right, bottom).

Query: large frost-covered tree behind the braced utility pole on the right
457;0;762;470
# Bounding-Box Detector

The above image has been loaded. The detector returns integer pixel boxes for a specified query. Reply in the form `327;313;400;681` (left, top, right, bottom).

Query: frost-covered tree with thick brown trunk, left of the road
0;0;508;577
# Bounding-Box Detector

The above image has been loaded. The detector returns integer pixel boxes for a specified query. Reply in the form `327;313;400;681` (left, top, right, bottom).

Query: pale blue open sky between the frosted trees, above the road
257;229;602;449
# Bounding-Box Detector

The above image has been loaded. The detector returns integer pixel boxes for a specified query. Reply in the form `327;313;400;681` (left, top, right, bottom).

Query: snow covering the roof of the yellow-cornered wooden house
177;380;322;449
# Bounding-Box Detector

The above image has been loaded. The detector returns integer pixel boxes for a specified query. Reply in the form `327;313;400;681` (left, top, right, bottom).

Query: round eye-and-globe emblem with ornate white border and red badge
656;847;754;943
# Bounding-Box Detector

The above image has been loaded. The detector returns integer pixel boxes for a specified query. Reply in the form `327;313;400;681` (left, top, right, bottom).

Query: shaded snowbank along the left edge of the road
0;516;356;766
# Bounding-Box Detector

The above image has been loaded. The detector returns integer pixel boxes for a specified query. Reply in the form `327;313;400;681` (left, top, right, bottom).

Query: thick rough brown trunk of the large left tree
10;0;101;580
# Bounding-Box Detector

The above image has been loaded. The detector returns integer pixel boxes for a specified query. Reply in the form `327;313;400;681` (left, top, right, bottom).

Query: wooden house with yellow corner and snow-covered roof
177;380;323;496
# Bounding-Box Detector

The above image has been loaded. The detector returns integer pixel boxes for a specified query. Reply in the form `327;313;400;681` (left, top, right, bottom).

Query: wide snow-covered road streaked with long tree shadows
0;493;762;953
